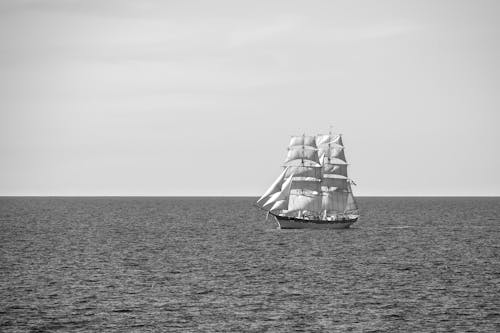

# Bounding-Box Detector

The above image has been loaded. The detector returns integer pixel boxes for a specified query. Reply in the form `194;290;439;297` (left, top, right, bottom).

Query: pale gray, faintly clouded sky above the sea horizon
0;0;500;196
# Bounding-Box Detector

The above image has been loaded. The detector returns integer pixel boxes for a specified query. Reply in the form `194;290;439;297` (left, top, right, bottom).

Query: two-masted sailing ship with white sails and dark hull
257;132;359;229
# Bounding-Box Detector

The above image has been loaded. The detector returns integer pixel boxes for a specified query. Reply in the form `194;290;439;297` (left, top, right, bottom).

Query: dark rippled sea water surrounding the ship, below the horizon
0;198;500;332
